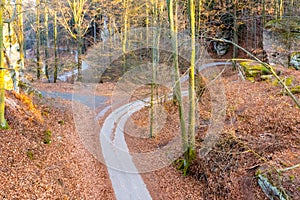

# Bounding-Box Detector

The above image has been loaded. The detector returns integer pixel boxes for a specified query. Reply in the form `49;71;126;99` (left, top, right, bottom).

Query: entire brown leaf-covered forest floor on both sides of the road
0;63;300;200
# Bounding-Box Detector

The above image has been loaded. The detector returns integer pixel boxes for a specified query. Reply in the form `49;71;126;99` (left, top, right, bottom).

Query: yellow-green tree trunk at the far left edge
0;0;7;129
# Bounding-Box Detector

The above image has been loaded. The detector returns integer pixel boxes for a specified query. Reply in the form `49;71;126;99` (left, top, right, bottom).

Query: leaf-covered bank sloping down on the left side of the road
0;92;114;199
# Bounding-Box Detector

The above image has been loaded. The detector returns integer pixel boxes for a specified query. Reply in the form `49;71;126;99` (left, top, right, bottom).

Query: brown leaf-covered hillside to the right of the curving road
125;67;300;200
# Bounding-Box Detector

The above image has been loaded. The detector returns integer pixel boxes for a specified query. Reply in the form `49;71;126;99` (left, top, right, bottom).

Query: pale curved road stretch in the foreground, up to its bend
100;101;152;200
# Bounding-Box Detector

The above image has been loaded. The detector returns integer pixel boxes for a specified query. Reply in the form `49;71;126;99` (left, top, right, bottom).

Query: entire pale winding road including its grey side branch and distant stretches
42;62;231;200
